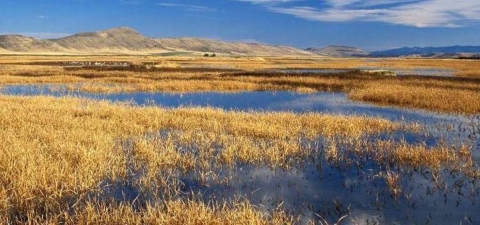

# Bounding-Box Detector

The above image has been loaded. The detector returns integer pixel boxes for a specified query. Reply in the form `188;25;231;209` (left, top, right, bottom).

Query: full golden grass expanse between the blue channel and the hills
0;56;480;114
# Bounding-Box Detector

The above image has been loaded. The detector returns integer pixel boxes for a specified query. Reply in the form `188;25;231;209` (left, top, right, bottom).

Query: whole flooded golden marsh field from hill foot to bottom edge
0;56;480;224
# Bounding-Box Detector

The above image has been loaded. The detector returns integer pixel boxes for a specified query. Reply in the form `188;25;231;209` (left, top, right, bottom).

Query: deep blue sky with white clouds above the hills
0;0;480;50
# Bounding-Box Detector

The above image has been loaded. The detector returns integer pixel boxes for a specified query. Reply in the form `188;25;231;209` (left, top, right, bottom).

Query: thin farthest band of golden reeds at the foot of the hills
0;56;480;78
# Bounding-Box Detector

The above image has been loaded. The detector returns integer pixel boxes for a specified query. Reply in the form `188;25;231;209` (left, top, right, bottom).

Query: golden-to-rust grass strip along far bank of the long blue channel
0;62;480;115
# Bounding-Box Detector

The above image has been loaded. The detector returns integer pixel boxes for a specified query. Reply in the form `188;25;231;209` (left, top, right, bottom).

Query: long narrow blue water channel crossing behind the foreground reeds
0;84;480;156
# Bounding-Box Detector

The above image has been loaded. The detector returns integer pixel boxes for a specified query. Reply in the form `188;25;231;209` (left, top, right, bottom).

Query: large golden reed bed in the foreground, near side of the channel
0;96;475;224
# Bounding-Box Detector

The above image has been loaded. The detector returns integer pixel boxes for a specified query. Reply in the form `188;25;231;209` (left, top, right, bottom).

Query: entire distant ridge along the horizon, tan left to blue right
0;27;480;59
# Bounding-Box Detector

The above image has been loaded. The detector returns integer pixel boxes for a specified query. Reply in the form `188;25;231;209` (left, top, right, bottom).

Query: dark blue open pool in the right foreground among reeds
191;164;480;224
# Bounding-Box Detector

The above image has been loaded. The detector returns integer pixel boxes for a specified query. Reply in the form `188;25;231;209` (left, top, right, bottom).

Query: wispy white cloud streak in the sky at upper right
239;0;480;27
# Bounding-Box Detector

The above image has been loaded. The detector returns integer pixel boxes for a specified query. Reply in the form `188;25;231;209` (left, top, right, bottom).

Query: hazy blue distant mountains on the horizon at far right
371;45;480;58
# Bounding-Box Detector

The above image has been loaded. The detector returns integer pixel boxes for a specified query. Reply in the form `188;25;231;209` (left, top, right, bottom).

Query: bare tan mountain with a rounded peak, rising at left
0;27;312;56
